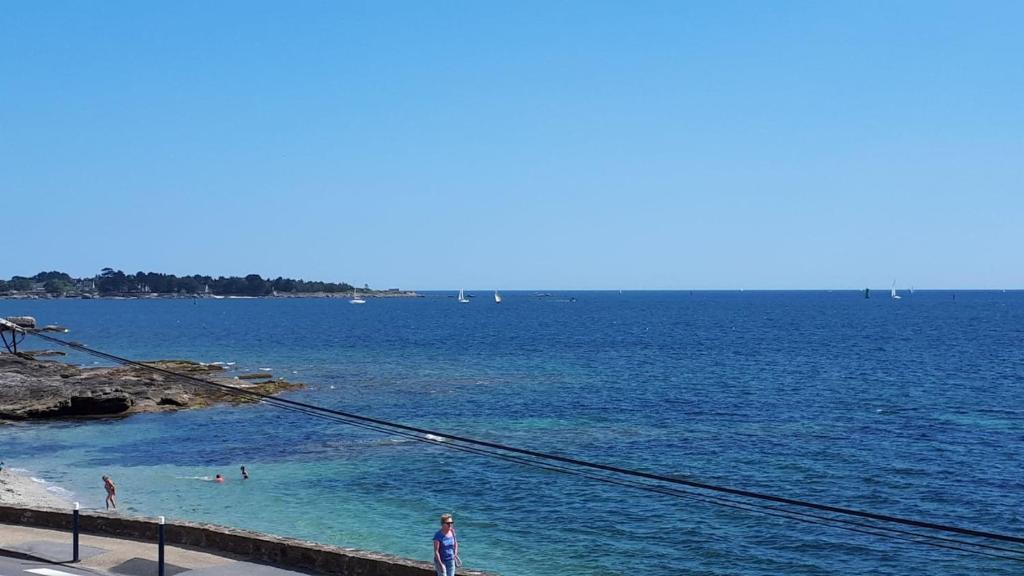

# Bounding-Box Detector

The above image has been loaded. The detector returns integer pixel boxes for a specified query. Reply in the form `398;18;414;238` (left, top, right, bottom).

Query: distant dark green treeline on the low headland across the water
0;268;352;296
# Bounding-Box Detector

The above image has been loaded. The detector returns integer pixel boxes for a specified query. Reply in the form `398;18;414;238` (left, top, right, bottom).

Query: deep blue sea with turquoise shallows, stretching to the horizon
0;291;1024;576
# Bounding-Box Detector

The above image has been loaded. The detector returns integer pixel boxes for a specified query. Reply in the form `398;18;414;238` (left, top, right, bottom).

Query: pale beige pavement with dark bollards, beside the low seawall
0;524;302;576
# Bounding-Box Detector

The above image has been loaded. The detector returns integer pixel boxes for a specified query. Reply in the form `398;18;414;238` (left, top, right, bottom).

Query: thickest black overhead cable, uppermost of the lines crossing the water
22;332;1024;549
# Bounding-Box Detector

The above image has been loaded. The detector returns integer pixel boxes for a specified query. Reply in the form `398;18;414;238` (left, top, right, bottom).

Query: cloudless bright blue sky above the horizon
0;0;1024;289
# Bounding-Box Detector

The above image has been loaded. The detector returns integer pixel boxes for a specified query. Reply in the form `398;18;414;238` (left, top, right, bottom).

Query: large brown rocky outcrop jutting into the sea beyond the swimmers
0;354;302;420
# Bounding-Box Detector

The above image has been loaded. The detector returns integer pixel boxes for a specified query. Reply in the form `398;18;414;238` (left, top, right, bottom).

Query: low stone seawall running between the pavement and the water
0;506;490;576
